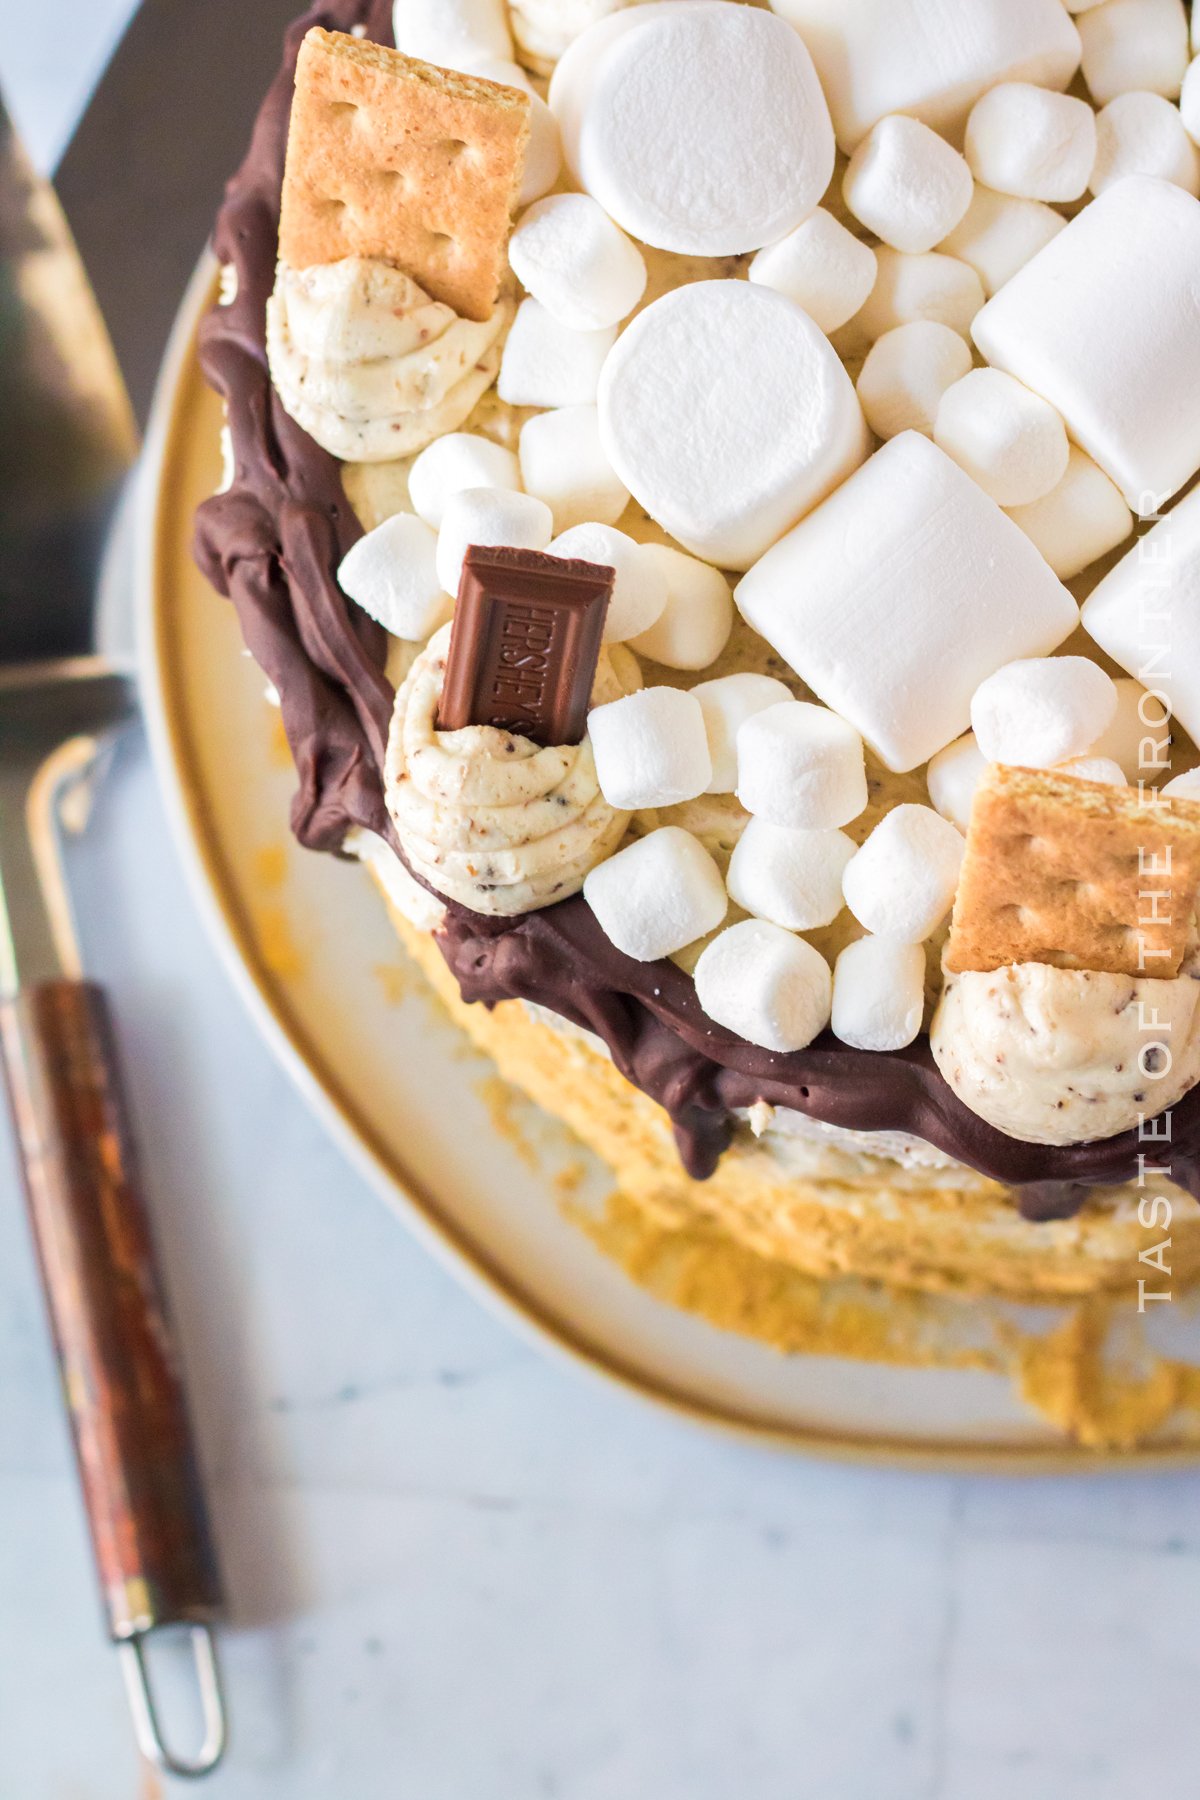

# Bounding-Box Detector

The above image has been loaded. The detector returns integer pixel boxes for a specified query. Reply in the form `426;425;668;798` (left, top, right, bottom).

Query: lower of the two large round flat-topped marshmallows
599;280;867;569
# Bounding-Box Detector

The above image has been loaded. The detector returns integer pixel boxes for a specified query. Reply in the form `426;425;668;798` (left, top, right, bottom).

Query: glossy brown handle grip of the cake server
0;981;221;1638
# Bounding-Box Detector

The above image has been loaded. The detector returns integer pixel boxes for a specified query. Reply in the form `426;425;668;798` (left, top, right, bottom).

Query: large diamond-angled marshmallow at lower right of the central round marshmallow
734;432;1079;770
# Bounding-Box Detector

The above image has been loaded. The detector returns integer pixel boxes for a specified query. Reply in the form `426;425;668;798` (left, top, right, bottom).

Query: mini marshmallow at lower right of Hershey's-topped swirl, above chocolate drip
583;824;729;963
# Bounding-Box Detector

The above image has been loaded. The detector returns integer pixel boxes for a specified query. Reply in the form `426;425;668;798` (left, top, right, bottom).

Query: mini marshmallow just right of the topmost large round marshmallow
842;113;975;256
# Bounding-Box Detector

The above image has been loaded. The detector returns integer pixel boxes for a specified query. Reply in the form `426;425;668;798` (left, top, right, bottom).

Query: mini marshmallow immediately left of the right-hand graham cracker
842;803;966;943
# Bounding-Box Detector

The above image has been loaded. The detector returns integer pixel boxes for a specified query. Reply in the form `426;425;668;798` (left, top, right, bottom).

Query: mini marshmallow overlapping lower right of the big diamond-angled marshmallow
972;657;1117;769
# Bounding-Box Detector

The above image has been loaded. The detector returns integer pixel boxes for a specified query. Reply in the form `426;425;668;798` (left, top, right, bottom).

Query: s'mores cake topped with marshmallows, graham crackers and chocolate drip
198;0;1200;1324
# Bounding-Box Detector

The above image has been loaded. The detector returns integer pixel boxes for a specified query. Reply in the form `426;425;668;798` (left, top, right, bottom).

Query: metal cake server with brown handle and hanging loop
0;94;225;1775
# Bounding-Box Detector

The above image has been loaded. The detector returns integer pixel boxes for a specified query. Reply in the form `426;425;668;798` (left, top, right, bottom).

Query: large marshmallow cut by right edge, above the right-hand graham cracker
1083;482;1200;740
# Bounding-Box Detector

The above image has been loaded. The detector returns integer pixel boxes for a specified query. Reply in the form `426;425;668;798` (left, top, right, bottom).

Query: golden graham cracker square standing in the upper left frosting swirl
279;25;529;319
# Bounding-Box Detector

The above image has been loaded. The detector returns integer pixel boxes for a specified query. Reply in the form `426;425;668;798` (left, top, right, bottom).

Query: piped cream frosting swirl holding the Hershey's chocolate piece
385;625;642;918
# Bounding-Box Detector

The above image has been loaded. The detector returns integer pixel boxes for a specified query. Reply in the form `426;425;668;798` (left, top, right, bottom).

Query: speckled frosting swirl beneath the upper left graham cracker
266;256;513;463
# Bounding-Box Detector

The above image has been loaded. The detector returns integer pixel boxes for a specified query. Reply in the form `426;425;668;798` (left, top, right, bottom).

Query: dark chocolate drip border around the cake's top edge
196;0;1200;1219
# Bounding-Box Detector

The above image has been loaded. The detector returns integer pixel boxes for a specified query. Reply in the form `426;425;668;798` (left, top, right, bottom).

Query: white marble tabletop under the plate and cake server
0;0;1200;1800
